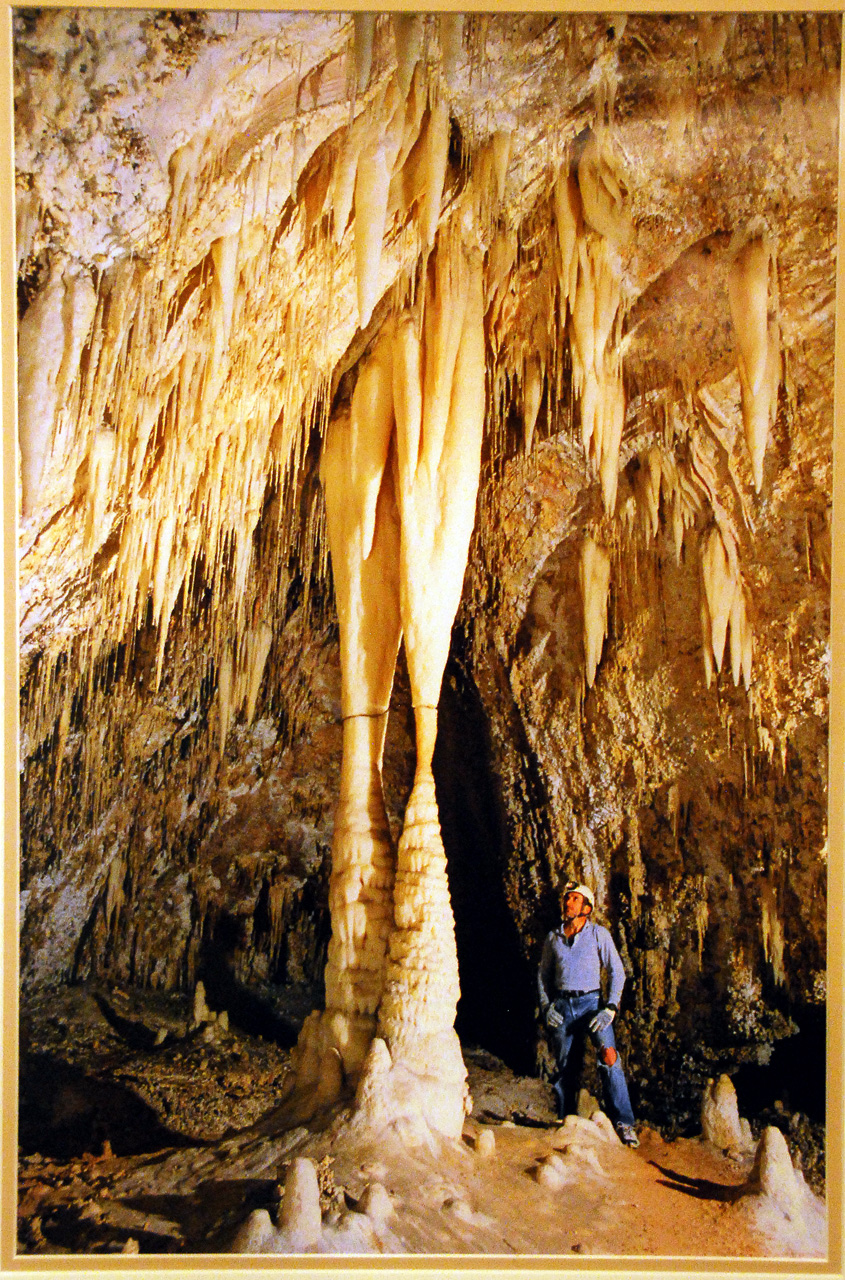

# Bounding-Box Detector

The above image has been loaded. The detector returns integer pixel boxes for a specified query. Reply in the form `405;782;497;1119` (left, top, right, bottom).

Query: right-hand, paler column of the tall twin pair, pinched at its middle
363;229;485;1137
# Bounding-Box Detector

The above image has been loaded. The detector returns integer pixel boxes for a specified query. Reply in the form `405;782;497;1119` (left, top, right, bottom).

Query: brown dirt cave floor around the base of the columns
18;986;826;1258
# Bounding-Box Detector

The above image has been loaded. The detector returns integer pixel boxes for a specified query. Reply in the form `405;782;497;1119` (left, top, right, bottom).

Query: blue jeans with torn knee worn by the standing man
548;991;634;1124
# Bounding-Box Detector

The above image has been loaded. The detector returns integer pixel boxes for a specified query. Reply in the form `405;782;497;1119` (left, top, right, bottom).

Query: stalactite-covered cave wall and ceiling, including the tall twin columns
14;10;840;1133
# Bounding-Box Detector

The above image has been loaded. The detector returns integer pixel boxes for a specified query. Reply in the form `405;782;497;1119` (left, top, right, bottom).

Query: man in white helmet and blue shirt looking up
538;884;639;1147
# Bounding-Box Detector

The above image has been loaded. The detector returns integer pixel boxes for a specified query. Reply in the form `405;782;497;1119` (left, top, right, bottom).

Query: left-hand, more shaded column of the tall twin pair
297;332;401;1101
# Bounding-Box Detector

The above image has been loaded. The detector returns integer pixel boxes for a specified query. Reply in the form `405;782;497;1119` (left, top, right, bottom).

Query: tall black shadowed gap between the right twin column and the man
434;664;536;1075
